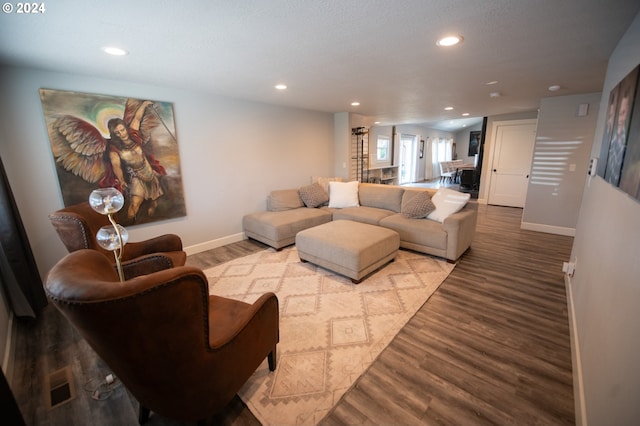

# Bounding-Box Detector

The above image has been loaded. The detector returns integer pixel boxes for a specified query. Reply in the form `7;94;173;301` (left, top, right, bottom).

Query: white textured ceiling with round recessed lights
0;0;640;129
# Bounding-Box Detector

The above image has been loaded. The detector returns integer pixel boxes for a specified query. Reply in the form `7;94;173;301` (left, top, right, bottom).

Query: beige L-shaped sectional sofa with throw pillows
243;182;477;262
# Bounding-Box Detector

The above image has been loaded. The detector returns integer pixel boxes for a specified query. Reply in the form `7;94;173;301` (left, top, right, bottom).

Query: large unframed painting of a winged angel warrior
40;89;184;225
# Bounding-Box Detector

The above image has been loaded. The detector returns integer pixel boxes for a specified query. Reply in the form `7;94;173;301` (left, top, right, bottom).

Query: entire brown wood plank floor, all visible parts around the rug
12;205;575;425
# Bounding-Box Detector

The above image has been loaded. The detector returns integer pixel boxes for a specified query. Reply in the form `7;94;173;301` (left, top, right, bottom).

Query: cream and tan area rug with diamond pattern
205;247;454;425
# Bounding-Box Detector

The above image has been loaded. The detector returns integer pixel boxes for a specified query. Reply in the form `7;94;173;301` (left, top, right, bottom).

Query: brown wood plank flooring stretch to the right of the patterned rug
322;205;575;425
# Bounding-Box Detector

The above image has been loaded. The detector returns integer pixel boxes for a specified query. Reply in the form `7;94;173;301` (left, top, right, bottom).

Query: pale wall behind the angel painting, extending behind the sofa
0;68;334;275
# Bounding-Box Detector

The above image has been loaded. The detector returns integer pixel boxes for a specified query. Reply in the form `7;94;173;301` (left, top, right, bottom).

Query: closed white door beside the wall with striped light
488;120;536;207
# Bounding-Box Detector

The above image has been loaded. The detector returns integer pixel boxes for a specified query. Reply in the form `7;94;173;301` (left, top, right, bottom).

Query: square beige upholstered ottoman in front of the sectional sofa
296;220;400;284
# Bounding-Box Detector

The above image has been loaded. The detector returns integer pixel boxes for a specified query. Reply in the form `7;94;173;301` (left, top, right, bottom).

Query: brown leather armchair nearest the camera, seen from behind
45;250;279;424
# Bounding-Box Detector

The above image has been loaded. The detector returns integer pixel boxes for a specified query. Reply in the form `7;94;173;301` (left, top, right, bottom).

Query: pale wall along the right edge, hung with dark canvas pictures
568;10;640;426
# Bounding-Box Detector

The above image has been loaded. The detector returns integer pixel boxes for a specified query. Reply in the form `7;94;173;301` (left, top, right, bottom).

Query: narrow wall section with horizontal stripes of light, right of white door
522;93;601;236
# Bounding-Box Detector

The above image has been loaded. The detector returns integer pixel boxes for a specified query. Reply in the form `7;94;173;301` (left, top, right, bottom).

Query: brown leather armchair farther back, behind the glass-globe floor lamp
49;201;187;279
